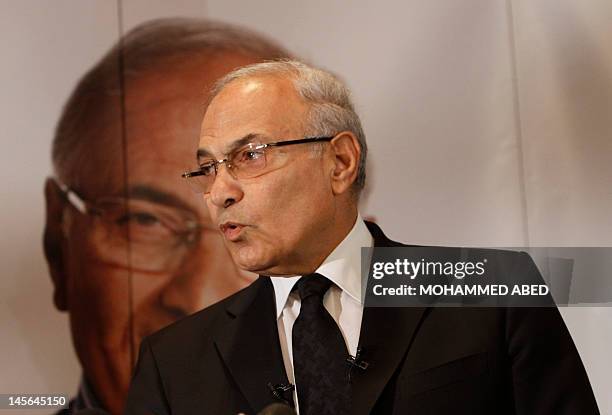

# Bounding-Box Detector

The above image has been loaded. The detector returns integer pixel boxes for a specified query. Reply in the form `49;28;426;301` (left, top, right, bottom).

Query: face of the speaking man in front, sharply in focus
199;77;338;275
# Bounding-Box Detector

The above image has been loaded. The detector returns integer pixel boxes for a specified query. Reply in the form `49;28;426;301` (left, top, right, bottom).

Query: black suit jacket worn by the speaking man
126;223;598;415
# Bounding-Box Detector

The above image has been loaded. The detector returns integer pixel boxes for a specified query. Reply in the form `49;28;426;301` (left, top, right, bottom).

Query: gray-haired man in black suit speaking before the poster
126;61;597;415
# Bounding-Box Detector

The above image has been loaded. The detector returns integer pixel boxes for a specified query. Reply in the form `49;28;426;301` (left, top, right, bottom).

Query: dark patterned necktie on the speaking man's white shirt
292;274;349;415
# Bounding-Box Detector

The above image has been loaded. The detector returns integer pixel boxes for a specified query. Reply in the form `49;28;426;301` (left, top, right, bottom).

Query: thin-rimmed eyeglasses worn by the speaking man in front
181;136;334;193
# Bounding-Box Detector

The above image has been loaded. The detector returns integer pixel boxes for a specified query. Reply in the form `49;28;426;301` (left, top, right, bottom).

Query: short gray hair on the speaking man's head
209;59;368;195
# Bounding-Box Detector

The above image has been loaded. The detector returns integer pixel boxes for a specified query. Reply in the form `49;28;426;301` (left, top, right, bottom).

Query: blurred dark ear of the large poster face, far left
43;178;68;311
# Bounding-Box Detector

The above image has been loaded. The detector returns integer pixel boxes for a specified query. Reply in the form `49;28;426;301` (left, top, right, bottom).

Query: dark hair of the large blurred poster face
52;18;291;178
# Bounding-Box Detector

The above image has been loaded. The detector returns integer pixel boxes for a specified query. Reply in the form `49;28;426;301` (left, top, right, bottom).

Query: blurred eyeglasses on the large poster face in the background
55;179;220;272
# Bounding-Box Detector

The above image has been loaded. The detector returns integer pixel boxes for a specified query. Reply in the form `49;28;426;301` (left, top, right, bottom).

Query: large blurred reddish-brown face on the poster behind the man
45;54;254;413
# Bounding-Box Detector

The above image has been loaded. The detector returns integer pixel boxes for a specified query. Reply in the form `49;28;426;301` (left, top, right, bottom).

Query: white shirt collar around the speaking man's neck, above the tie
270;214;373;318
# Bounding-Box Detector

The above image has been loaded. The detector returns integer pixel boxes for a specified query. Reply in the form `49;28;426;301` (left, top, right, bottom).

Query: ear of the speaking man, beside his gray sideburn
331;131;361;194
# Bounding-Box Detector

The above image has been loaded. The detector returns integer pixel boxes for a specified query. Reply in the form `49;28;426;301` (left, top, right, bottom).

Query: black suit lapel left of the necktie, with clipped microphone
215;277;291;412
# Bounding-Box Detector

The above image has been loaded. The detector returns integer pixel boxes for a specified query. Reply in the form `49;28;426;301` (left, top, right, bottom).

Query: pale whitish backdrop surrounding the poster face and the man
0;0;612;413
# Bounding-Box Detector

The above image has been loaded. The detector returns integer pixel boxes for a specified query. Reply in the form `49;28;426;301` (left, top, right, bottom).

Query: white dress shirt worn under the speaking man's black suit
270;214;373;413
